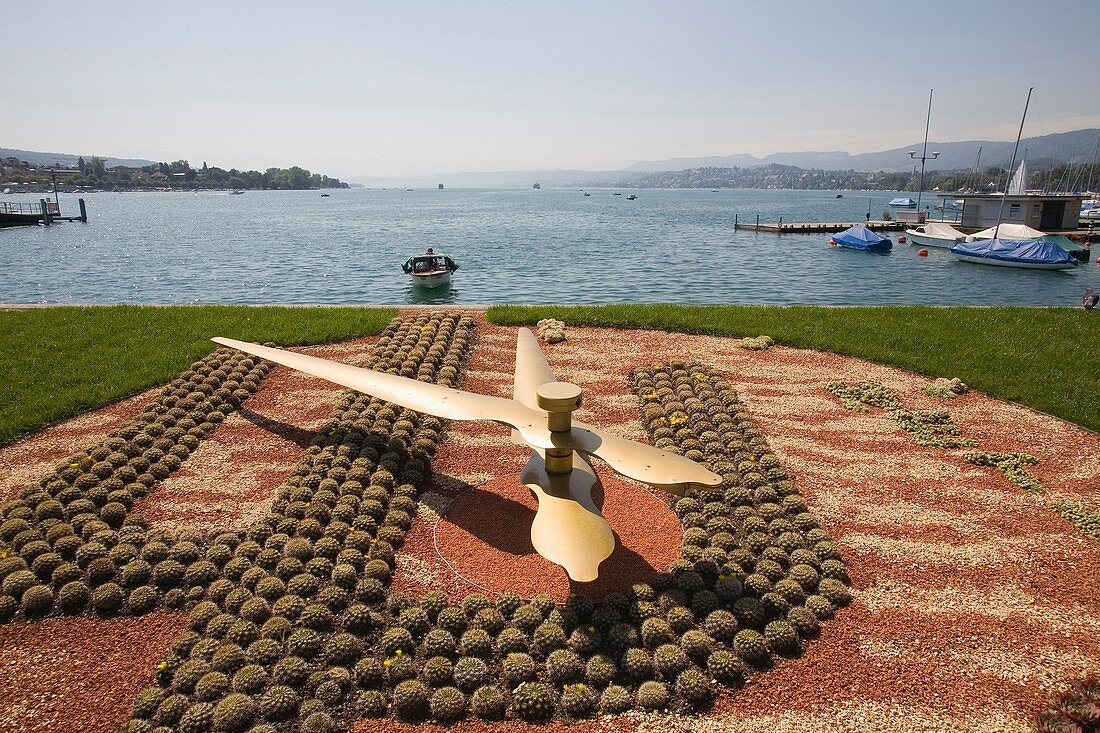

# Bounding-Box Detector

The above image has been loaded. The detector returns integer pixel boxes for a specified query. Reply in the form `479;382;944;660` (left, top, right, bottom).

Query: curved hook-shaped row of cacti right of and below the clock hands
251;356;849;723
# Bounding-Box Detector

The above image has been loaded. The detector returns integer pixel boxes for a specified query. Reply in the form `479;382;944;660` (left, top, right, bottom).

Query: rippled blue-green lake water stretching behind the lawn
0;189;1100;306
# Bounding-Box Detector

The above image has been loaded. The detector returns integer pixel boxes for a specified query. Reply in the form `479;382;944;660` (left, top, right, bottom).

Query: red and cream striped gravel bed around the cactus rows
0;319;1100;733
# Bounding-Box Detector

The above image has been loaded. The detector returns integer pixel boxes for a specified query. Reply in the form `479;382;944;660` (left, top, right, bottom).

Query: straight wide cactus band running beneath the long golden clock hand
122;313;474;732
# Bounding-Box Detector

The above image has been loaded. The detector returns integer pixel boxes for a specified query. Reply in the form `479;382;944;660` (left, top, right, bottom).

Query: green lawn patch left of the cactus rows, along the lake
0;306;396;445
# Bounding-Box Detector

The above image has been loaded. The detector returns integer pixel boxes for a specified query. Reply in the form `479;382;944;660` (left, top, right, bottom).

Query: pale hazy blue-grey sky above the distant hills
8;0;1100;179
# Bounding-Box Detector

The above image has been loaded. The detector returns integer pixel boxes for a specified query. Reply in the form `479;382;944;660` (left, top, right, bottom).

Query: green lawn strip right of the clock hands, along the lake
488;305;1100;430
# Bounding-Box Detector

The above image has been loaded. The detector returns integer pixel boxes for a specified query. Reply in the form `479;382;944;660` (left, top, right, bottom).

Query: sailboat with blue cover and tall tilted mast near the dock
952;87;1080;270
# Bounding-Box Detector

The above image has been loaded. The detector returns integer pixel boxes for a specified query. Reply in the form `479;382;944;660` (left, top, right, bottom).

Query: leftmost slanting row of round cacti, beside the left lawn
0;349;270;622
